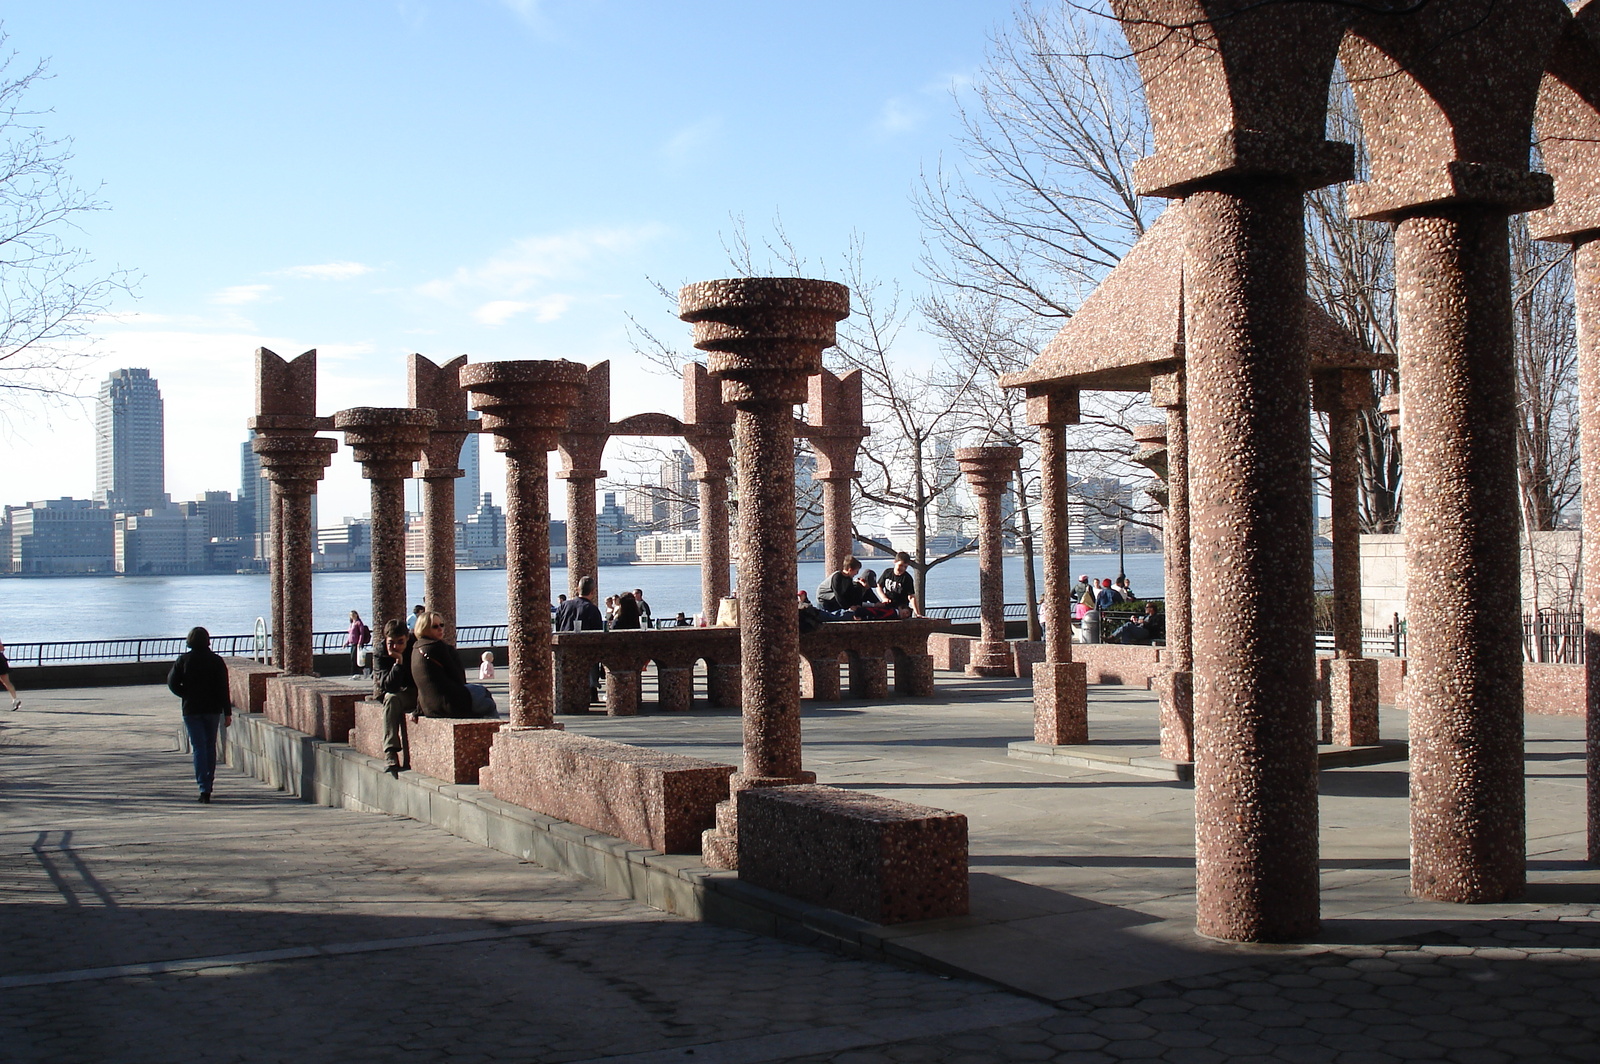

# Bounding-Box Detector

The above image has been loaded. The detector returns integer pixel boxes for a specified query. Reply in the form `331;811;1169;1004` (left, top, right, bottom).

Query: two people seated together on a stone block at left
376;610;496;776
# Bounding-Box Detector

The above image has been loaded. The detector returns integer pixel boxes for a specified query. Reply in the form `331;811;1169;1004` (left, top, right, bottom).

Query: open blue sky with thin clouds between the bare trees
0;0;1011;525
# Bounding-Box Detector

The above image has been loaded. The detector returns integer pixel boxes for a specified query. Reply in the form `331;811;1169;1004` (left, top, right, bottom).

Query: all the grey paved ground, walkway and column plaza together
0;674;1600;1064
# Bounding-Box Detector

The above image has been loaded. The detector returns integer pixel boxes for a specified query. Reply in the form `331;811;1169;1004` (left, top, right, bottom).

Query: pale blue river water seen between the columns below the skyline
9;554;1203;643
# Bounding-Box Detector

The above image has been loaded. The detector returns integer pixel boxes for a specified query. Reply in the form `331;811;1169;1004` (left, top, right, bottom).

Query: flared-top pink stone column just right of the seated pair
461;362;587;729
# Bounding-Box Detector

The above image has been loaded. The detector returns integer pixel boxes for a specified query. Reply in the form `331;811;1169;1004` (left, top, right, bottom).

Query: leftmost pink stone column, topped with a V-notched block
250;347;339;675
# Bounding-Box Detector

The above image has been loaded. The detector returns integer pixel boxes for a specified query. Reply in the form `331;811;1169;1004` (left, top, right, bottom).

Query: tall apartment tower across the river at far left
94;370;166;514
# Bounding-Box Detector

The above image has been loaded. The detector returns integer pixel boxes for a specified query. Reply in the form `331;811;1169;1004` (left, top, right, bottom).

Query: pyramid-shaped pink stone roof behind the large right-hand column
1000;203;1395;392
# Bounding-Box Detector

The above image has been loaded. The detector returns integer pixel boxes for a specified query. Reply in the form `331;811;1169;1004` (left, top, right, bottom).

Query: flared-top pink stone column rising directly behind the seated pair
333;406;438;674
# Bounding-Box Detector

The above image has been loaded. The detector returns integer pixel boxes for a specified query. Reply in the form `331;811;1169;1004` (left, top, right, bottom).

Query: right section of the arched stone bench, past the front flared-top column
800;618;950;701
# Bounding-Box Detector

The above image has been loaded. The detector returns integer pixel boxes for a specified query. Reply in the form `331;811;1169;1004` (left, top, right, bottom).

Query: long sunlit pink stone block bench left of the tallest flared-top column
478;728;733;853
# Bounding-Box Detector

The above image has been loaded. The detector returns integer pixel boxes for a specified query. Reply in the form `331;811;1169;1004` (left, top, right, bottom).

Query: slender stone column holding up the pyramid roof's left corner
1027;390;1090;746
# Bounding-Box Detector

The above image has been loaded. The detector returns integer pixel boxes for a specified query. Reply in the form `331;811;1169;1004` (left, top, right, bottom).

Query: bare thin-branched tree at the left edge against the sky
0;41;130;408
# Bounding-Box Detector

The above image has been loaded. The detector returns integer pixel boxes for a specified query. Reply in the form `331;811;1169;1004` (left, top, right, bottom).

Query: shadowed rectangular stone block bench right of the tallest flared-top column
738;784;968;923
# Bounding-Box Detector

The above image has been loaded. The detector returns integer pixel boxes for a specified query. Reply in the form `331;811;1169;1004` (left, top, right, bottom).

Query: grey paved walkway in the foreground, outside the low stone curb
0;688;1600;1064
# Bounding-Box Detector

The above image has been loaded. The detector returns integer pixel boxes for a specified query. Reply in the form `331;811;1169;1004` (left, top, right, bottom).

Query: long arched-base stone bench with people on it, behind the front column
550;618;950;717
